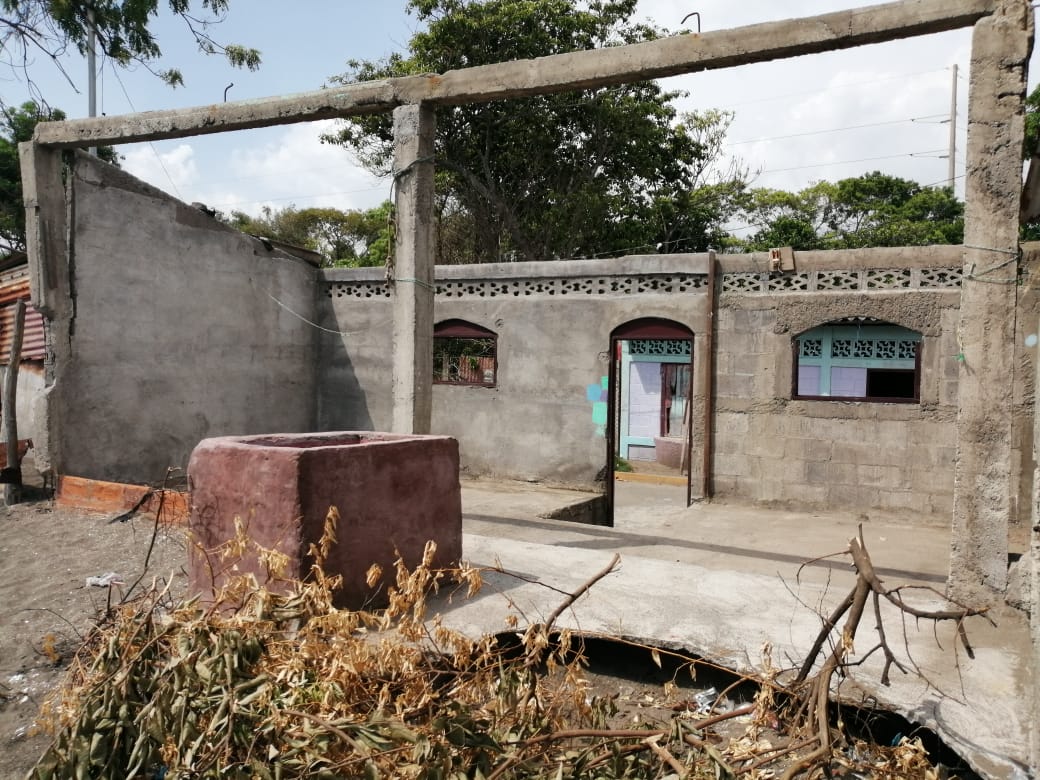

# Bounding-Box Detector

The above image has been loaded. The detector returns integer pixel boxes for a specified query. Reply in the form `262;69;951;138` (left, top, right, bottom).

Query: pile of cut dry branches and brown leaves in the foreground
30;510;985;780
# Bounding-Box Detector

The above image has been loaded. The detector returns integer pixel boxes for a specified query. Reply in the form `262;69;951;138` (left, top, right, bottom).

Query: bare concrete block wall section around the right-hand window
712;256;958;520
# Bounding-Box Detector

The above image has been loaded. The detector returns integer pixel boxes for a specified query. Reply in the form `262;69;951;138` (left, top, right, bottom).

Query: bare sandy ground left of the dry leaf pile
0;500;185;780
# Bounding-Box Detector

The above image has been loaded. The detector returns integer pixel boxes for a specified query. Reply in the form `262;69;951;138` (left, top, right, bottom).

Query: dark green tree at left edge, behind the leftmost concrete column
0;101;119;255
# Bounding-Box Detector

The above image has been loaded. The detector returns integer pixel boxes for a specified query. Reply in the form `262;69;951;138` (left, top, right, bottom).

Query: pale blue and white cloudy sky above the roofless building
0;0;1040;232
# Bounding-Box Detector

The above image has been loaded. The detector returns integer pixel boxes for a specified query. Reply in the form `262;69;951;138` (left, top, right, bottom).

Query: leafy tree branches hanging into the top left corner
0;0;260;97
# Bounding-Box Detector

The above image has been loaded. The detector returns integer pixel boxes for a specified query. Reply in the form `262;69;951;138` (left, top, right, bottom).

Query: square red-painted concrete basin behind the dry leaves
188;432;462;608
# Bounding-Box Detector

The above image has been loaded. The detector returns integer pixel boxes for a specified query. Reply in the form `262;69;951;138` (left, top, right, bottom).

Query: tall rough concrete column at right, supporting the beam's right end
945;0;1033;603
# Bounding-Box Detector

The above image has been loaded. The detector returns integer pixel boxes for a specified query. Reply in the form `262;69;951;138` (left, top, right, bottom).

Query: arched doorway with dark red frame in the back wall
605;317;694;525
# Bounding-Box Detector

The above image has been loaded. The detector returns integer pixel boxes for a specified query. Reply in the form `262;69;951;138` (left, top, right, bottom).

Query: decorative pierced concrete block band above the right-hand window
722;268;964;293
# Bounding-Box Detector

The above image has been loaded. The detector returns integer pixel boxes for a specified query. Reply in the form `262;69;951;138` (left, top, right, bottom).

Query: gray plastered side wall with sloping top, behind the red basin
37;153;316;483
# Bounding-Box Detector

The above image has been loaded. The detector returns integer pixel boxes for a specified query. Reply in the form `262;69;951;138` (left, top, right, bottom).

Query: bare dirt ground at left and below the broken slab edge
0;500;965;780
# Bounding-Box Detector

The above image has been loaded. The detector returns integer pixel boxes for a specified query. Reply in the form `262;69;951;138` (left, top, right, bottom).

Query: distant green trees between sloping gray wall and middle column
226;202;390;266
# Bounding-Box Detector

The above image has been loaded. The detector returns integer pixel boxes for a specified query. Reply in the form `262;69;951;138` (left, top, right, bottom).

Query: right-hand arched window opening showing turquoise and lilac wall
794;317;920;404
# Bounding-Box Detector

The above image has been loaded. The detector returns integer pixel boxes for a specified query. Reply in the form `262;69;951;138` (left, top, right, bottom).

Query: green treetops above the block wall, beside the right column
740;172;964;251
